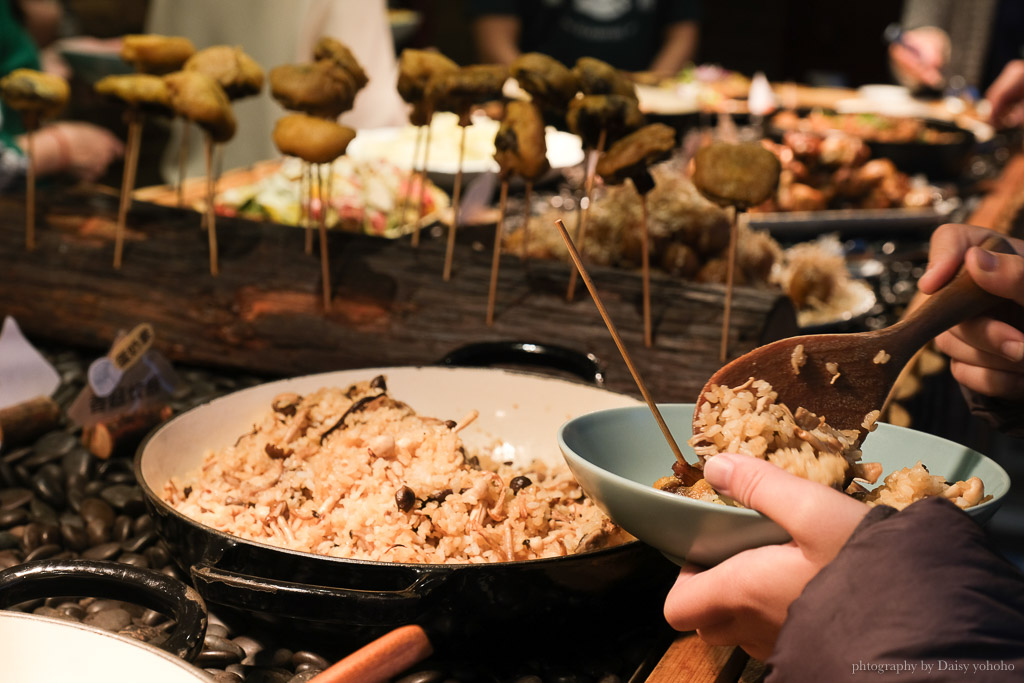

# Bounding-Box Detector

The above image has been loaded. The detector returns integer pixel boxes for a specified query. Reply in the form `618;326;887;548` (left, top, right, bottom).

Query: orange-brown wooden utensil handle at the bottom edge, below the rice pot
309;626;434;683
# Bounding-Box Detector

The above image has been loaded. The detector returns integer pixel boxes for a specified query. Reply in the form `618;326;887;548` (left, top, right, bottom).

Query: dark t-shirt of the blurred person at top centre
467;0;699;71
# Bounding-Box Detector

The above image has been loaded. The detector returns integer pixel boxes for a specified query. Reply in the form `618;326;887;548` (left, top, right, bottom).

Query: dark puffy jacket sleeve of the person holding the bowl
768;499;1024;683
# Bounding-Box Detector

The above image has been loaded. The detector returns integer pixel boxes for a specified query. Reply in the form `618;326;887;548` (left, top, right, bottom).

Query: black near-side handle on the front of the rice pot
191;564;449;624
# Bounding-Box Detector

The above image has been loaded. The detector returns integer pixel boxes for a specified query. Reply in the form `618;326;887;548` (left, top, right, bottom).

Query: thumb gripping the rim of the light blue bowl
705;454;867;555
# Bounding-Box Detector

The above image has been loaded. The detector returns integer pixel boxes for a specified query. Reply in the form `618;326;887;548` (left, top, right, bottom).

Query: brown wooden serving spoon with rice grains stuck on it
693;236;1013;444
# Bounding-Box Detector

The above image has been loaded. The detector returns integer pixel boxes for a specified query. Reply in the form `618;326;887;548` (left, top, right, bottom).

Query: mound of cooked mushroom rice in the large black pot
164;377;632;564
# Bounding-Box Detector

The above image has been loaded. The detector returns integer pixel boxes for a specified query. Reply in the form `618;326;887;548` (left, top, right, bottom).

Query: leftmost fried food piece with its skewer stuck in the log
0;69;70;251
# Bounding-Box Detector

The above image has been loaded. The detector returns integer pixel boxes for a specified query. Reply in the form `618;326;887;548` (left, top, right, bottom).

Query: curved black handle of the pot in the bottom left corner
0;559;207;661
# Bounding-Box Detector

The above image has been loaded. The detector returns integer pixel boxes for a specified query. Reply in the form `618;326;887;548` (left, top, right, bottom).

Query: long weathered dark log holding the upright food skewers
0;187;796;401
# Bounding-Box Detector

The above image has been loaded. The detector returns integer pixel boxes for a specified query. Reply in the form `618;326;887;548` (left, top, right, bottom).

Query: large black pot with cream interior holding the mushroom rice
135;367;678;652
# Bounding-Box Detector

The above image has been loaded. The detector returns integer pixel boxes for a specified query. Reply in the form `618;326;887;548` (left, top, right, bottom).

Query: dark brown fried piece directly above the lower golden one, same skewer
270;61;357;119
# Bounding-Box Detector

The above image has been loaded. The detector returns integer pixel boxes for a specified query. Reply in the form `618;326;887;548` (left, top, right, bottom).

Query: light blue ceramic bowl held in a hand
558;403;1010;566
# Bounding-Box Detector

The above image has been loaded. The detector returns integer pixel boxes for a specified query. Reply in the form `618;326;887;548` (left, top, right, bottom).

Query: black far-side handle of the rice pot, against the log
437;341;604;386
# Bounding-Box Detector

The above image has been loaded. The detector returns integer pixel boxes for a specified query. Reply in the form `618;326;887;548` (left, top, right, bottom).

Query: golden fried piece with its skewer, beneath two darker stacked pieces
273;114;355;309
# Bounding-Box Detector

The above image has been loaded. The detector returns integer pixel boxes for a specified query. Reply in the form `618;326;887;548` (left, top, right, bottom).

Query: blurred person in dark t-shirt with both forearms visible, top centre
467;0;699;78
